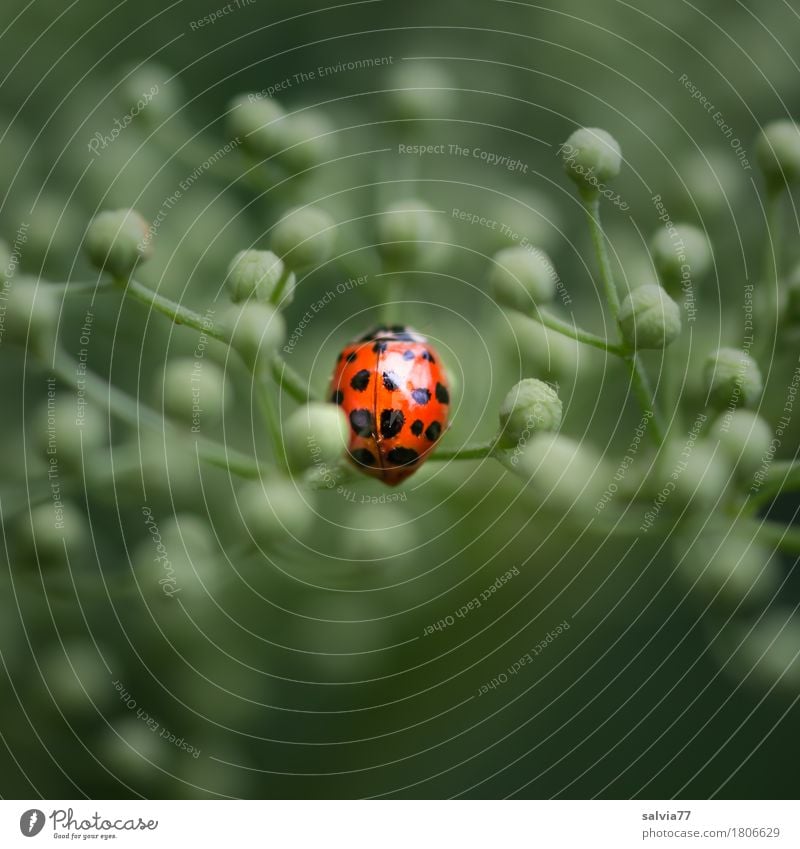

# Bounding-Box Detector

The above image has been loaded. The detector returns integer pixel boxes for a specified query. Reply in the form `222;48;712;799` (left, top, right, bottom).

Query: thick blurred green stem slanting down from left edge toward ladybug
53;350;270;478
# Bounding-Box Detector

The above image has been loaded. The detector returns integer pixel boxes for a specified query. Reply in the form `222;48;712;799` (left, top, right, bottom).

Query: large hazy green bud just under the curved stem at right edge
673;518;780;609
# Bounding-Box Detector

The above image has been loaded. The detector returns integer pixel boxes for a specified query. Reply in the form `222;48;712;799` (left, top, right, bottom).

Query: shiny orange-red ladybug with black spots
330;324;450;486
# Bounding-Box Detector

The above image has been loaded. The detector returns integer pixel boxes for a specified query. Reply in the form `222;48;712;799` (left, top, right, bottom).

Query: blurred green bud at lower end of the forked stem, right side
653;438;733;511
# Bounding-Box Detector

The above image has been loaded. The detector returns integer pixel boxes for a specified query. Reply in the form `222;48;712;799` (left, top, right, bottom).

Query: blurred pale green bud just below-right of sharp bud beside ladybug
510;433;609;514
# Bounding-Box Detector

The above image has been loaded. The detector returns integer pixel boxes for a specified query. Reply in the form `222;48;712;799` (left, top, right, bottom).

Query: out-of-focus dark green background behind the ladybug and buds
0;0;800;798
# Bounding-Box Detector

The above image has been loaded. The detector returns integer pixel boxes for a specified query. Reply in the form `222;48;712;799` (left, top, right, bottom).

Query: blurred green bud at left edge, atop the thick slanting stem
0;277;58;355
